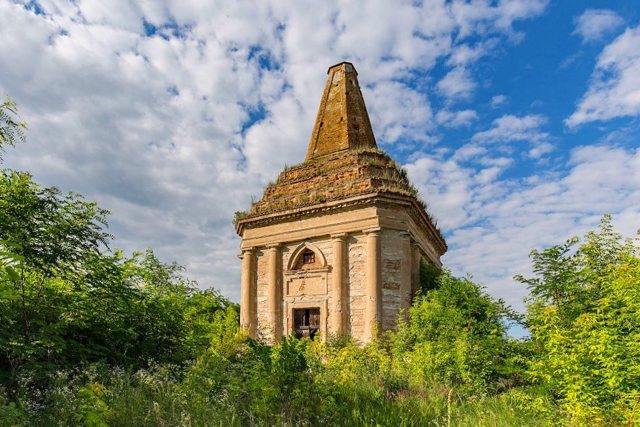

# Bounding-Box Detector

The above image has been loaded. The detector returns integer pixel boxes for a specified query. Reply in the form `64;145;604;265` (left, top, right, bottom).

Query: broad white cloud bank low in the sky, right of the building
405;145;640;309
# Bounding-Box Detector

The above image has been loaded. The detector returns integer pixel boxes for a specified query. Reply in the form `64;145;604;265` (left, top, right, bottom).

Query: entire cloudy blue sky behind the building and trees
0;0;640;309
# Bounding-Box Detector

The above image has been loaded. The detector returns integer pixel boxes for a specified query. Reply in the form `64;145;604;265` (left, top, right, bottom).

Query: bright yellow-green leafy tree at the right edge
518;216;640;425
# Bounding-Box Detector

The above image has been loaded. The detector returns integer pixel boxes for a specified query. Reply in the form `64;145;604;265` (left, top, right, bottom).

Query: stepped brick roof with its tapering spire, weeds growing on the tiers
235;62;447;253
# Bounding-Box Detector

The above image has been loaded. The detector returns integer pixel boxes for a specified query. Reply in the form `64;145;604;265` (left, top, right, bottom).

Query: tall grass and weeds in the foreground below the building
0;340;552;427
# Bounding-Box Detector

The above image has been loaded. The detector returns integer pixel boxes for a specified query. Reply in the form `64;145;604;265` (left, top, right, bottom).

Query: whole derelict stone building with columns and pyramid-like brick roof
235;62;447;342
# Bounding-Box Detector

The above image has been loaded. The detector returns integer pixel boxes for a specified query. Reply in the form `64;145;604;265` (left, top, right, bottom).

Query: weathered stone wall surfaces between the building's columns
255;229;416;341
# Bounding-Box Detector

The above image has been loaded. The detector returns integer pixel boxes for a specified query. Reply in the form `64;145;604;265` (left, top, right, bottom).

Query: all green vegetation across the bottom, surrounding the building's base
0;100;640;426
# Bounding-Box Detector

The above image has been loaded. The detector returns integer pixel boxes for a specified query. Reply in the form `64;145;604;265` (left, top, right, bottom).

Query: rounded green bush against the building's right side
393;271;519;395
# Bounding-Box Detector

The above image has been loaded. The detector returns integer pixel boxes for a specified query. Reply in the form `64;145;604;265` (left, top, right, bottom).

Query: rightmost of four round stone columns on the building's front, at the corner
364;228;382;341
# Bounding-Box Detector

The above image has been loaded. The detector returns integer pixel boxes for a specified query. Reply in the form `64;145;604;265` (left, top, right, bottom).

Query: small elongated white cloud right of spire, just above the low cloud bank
471;114;549;143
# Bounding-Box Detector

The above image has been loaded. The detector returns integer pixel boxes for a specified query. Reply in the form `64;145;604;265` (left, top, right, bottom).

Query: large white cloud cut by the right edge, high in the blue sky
565;27;640;128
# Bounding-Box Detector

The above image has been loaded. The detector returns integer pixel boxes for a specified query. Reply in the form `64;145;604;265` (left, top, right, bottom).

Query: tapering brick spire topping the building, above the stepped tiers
306;62;377;160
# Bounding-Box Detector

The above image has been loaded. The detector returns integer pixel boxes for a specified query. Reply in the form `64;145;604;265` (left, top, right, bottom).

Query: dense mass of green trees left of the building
0;172;237;387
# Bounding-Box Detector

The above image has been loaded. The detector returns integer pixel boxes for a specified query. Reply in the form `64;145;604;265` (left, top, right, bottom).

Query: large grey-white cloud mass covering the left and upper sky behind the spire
0;0;546;298
